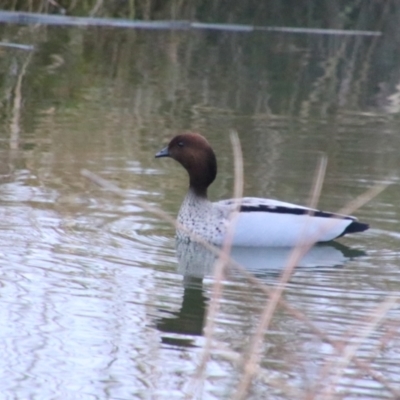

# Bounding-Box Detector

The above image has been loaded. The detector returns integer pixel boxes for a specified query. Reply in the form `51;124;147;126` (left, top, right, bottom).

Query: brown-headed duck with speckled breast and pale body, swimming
155;132;369;247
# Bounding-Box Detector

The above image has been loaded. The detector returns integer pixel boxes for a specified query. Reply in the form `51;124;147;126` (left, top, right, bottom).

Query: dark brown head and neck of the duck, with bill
156;133;217;197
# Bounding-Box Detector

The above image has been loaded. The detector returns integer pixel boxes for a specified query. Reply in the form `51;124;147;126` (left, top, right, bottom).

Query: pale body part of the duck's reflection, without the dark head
176;240;364;278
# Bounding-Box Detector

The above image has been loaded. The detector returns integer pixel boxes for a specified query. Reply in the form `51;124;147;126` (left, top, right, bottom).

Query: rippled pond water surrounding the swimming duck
0;18;400;400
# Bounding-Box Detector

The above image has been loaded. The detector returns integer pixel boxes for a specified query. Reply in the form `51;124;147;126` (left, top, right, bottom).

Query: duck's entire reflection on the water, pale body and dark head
157;240;364;347
